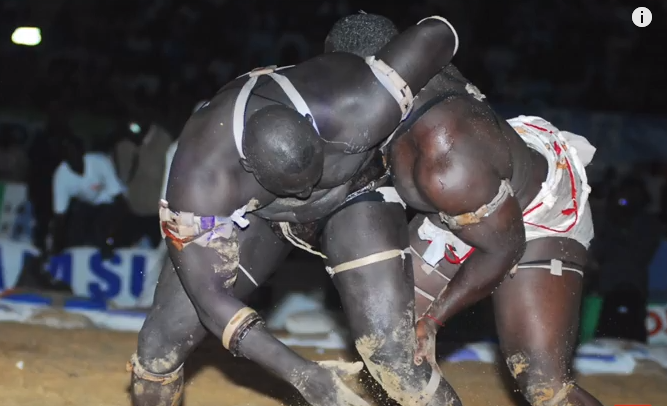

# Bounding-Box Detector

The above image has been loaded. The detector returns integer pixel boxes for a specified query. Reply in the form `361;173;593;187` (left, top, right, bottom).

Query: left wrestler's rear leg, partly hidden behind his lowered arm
131;215;291;406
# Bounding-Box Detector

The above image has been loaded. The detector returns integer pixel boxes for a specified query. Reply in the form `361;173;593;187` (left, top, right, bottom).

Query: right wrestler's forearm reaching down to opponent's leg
427;250;516;323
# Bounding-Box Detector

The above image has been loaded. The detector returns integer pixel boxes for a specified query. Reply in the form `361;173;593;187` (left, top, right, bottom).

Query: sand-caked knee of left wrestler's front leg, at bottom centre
355;331;439;406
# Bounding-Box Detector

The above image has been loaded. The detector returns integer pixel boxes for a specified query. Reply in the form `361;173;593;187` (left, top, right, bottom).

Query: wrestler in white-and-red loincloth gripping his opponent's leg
326;14;601;406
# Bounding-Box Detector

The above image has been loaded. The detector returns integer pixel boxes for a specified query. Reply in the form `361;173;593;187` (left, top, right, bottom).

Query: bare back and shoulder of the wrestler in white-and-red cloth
390;68;547;213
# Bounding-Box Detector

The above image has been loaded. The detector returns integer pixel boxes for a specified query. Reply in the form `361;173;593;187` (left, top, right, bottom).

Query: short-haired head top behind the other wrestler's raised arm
324;13;398;58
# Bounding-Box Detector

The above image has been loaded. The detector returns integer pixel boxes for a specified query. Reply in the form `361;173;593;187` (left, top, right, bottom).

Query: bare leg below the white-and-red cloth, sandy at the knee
493;238;602;406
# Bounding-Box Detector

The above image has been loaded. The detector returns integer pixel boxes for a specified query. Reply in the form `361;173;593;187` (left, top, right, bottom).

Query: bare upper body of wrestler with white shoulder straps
167;20;454;223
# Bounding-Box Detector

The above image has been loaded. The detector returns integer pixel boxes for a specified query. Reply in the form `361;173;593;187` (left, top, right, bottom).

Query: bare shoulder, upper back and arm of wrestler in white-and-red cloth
390;76;528;322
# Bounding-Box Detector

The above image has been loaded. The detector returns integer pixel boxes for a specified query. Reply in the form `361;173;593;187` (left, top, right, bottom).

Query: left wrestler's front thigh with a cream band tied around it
322;202;414;337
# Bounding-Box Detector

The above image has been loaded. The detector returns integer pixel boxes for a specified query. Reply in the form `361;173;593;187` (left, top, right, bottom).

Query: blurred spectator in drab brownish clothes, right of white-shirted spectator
114;117;172;248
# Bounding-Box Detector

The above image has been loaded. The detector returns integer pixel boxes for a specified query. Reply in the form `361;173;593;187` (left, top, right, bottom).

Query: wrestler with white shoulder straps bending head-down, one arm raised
129;18;464;406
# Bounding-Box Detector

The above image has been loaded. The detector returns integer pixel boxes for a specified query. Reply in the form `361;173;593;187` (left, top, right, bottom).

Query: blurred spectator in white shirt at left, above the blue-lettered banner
52;137;127;258
